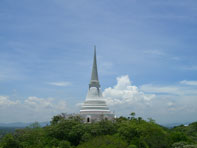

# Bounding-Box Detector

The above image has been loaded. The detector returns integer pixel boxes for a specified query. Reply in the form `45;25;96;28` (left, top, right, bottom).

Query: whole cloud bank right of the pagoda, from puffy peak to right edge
103;75;197;124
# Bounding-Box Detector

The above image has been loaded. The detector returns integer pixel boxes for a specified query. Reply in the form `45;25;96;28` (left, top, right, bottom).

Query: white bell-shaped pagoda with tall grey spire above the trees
80;47;114;123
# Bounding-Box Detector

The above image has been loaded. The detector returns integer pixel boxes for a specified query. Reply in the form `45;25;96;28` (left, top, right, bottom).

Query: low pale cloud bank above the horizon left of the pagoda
0;96;68;122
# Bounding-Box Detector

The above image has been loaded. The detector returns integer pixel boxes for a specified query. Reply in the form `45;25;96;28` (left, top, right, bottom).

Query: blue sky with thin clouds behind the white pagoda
0;0;197;123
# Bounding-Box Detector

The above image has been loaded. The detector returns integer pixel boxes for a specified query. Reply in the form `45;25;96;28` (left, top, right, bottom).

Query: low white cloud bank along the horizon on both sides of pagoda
0;75;197;124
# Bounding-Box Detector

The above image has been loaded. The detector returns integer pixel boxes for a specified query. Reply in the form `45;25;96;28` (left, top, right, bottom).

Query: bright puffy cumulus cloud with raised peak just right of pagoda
103;75;155;105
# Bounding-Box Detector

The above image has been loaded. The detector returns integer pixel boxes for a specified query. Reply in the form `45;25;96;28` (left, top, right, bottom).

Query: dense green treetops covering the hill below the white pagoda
0;113;197;148
